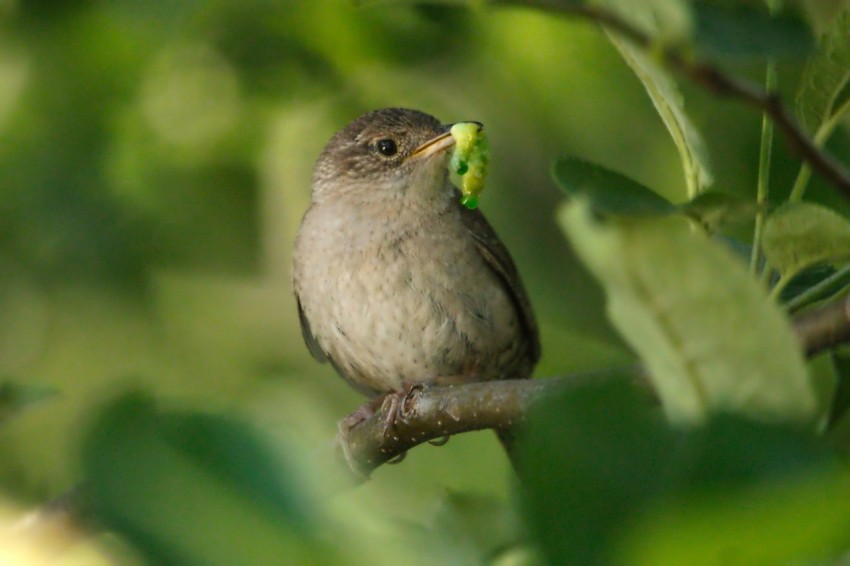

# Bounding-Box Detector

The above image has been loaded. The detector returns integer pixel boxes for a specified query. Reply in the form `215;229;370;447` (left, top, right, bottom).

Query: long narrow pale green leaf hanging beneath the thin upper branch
608;37;712;198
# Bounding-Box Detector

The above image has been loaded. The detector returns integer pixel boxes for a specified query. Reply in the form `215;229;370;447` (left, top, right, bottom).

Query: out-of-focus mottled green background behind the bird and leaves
0;0;844;564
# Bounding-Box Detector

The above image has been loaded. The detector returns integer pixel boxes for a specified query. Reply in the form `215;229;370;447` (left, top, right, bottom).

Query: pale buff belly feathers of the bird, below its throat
296;215;522;398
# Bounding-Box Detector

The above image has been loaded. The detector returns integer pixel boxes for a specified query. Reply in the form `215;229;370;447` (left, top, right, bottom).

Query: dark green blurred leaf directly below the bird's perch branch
518;379;676;564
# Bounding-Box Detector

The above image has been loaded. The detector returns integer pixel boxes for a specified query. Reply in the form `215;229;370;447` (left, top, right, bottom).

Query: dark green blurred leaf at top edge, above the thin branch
693;0;814;59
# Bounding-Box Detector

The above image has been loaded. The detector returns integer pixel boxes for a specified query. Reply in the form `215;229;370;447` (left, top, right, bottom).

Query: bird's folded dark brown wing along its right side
458;203;540;363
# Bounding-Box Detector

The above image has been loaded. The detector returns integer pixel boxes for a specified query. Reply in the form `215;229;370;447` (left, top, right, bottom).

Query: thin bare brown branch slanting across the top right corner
491;0;850;199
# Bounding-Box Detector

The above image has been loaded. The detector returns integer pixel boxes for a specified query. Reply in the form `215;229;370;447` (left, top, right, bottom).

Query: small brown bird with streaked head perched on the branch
293;108;540;426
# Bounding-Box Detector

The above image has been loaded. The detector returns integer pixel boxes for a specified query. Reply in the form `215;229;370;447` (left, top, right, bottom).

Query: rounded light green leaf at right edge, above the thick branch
762;202;850;280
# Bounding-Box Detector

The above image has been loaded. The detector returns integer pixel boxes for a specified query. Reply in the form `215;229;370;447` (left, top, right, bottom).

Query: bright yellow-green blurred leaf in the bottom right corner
620;458;850;566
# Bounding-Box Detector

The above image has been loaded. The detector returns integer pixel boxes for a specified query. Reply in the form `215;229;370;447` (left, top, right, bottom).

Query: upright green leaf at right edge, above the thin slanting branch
796;5;850;139
